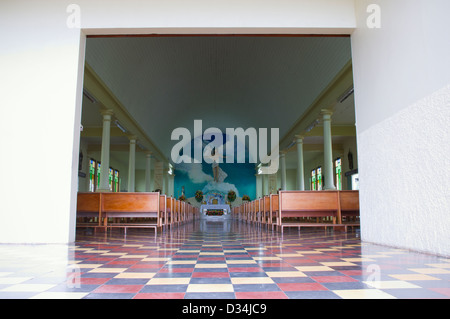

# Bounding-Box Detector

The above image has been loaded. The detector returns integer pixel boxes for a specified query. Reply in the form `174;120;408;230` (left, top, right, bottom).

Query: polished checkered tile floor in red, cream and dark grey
0;220;450;299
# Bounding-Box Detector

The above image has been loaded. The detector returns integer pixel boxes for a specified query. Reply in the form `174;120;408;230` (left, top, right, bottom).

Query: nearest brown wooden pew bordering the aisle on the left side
101;193;162;237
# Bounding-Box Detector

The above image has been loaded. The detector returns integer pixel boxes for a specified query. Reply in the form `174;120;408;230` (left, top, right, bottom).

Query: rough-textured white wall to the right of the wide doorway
352;0;450;256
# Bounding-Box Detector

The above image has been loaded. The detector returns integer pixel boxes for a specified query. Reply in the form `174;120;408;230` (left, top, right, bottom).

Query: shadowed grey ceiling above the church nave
82;36;355;170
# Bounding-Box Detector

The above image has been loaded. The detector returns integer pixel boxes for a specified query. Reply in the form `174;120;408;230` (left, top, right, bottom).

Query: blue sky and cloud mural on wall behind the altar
174;134;256;201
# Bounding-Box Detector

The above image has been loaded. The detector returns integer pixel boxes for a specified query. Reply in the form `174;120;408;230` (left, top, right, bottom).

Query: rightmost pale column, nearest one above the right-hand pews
322;110;336;190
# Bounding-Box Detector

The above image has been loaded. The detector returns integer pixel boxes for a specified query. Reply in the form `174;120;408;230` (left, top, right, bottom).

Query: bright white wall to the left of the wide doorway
0;1;83;243
